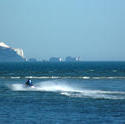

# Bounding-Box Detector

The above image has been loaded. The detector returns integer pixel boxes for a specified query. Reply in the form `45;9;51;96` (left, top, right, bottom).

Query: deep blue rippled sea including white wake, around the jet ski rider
0;62;125;124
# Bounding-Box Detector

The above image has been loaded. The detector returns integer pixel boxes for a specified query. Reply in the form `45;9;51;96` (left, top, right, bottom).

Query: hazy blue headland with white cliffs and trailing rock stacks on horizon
0;42;80;62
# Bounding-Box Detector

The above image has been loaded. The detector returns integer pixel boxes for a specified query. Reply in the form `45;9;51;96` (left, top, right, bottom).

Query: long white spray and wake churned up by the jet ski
9;81;125;99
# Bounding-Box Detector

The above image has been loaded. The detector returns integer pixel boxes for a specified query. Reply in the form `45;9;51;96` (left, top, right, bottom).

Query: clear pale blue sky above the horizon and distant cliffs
0;0;125;61
